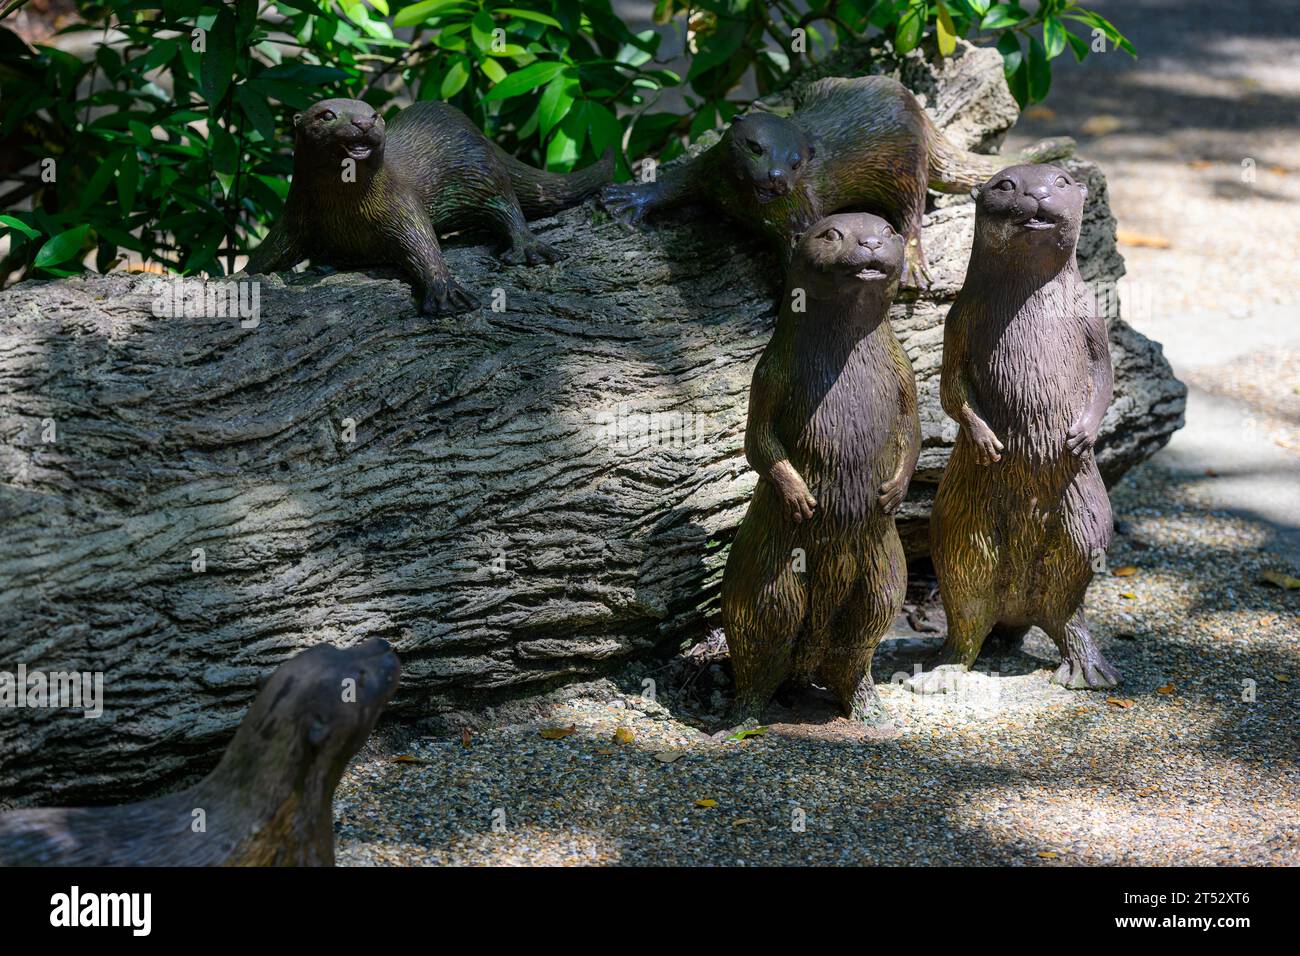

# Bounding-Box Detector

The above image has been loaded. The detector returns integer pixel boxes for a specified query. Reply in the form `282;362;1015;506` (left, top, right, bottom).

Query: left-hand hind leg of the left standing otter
722;516;807;724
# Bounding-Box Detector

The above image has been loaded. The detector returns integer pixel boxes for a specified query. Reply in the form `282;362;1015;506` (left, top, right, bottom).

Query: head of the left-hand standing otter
790;212;905;299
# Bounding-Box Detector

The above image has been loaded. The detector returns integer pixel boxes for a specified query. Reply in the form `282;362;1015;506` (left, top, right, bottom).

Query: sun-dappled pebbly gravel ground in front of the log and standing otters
334;464;1300;866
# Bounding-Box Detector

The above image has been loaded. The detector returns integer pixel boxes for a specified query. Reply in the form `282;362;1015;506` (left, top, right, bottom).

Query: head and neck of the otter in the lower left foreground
215;639;400;804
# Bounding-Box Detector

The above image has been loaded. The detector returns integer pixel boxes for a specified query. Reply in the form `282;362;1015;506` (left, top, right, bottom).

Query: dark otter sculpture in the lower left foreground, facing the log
0;639;400;866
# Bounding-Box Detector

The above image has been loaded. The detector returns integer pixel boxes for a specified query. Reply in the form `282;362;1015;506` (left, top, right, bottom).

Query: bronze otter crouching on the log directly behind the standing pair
601;77;1074;285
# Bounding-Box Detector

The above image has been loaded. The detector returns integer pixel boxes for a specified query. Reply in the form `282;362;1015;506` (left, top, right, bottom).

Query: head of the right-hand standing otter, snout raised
971;164;1088;272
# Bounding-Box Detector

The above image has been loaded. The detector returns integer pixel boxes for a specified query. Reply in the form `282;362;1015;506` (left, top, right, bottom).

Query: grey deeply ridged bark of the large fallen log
0;47;1184;803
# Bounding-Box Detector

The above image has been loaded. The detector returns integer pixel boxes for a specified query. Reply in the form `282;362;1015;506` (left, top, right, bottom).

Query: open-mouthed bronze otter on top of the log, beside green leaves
247;99;614;315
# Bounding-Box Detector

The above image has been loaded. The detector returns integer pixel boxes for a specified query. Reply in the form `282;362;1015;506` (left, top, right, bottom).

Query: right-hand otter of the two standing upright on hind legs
913;165;1119;689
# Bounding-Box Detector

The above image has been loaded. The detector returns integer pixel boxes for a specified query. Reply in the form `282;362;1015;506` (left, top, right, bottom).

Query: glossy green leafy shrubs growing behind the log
0;0;1132;284
